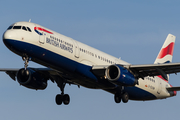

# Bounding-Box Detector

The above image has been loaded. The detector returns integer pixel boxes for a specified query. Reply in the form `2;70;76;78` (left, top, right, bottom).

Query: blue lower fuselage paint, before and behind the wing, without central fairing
4;40;156;100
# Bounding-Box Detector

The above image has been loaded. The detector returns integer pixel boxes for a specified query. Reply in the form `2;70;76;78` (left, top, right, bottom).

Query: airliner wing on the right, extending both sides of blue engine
92;63;180;80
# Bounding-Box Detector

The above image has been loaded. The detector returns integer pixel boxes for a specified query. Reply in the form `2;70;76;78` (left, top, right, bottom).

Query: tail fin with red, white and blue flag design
154;34;176;81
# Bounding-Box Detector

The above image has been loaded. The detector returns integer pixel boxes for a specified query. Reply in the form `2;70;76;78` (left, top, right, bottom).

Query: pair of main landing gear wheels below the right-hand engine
114;92;129;103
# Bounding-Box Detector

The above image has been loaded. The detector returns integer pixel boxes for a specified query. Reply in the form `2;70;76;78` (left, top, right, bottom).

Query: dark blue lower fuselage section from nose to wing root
6;40;97;80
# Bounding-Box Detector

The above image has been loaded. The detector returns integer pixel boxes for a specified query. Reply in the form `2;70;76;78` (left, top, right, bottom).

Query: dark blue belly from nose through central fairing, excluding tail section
4;40;115;89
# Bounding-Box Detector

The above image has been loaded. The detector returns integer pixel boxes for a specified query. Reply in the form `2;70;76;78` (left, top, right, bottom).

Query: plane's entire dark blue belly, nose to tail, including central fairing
2;40;160;100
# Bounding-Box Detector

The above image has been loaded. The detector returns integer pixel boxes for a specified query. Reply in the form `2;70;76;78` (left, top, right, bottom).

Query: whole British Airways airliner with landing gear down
0;22;180;105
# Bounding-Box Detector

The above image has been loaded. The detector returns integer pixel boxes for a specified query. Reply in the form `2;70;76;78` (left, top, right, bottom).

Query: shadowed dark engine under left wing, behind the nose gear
17;68;47;90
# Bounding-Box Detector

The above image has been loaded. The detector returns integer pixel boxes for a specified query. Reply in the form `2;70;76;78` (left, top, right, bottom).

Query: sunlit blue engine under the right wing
105;65;137;86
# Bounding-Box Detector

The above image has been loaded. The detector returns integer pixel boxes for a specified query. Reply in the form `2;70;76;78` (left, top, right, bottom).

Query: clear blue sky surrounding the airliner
0;0;180;120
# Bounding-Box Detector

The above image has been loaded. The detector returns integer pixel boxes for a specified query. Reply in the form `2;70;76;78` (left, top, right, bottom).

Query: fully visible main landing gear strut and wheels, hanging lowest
55;77;70;105
